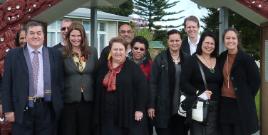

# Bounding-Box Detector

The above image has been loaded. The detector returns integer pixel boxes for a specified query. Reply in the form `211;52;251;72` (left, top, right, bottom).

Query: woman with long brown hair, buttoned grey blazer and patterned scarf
60;22;97;135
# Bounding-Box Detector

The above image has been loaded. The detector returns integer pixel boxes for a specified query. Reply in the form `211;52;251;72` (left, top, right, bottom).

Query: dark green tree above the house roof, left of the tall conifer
99;0;134;16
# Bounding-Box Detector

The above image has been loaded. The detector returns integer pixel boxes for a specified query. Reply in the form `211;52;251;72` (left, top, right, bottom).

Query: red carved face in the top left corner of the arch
3;0;25;24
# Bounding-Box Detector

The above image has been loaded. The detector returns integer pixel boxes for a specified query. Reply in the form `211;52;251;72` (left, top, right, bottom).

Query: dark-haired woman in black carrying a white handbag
181;32;221;135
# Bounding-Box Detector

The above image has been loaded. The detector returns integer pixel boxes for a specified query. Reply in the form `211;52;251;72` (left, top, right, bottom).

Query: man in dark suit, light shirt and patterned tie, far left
2;21;63;135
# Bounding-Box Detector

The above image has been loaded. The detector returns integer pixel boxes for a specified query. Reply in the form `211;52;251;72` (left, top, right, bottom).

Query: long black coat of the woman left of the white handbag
149;49;189;128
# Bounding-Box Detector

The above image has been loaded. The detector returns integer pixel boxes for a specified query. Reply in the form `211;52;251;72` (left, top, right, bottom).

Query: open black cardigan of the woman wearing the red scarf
94;59;148;128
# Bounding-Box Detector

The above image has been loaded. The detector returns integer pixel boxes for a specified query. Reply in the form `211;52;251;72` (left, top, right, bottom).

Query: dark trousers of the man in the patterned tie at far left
12;102;57;135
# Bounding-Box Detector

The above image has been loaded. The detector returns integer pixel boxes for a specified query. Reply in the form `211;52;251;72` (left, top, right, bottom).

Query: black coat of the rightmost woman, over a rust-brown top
219;50;260;134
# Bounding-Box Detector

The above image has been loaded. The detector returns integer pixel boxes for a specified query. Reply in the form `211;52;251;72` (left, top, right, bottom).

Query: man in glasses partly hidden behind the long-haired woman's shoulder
53;18;72;49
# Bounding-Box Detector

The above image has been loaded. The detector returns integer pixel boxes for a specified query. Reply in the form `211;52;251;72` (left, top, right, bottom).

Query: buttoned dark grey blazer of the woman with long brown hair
63;47;98;103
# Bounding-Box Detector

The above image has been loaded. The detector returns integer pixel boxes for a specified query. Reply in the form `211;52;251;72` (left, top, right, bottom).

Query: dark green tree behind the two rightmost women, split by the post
201;9;261;60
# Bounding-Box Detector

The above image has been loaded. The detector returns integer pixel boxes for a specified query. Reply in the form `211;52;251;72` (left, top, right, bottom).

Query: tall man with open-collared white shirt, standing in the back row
181;16;200;55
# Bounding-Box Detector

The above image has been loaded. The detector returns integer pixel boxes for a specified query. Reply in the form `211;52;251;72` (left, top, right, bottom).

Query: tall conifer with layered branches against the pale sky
134;0;183;30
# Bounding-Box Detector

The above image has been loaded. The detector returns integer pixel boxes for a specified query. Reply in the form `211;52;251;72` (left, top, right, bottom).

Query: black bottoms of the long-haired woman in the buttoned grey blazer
59;101;93;135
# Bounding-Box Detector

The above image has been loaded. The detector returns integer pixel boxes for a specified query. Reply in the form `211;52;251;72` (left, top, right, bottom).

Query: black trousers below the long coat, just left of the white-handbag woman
156;114;189;135
